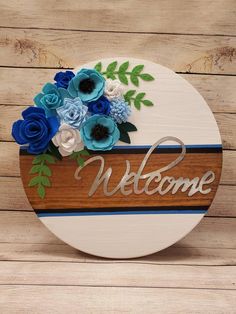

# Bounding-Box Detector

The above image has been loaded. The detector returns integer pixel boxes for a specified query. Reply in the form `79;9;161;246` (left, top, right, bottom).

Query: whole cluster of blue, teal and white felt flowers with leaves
12;61;153;198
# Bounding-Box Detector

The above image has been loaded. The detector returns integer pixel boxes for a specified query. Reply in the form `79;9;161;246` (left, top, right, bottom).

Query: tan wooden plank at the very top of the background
1;0;236;35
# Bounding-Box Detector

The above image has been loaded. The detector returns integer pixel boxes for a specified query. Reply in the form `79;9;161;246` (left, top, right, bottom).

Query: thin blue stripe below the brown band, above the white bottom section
37;209;207;217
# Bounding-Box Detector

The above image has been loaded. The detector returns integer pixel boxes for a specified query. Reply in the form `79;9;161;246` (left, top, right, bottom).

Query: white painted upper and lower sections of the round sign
36;58;221;258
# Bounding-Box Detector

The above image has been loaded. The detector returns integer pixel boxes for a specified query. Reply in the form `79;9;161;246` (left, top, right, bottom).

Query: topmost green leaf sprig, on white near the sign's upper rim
94;61;154;87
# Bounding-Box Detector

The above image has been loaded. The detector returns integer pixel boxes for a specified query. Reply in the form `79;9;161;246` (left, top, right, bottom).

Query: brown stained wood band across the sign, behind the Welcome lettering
20;153;222;209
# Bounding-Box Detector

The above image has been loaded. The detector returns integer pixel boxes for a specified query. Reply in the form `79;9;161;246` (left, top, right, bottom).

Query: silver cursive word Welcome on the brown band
75;136;215;196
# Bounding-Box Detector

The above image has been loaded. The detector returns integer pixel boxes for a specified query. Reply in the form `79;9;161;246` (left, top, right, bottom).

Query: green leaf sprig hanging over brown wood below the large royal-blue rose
28;154;55;199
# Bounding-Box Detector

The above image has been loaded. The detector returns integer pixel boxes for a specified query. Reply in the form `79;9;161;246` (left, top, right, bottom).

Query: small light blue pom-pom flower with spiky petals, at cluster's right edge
109;98;131;123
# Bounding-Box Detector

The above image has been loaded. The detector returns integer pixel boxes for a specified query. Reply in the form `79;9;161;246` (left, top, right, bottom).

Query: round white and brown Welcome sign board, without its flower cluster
20;58;222;258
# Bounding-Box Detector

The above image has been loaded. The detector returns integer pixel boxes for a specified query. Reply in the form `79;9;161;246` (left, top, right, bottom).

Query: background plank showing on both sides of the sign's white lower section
0;211;236;249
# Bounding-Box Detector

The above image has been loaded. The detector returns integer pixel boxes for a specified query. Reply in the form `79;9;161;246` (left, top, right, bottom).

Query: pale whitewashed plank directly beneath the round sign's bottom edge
0;261;236;290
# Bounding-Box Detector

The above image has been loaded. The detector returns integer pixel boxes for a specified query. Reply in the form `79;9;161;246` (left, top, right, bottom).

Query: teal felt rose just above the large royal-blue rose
34;83;70;117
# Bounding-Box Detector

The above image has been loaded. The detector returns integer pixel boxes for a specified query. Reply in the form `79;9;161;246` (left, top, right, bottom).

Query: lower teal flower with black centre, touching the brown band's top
80;114;120;150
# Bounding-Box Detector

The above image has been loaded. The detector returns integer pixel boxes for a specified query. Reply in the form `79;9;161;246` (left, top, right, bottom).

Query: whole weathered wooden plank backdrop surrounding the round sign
0;0;236;313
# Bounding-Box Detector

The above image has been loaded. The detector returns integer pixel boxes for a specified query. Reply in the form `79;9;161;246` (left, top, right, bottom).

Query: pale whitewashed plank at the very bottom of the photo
0;285;236;314
